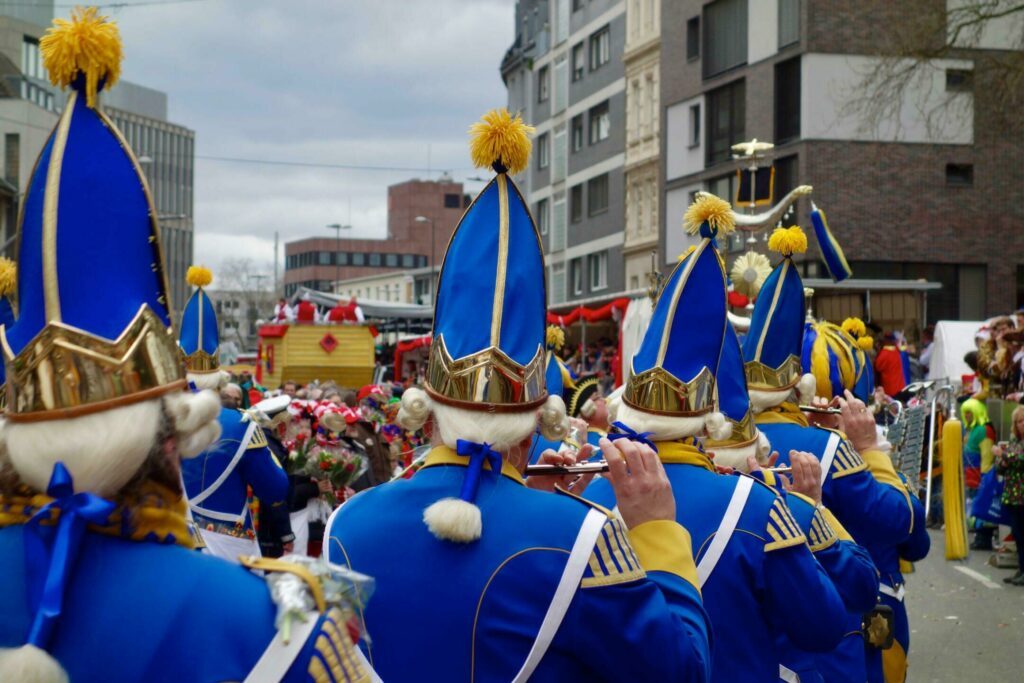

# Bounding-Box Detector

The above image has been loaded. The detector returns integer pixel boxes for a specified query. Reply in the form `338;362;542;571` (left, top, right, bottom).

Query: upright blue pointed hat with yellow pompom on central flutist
426;110;548;412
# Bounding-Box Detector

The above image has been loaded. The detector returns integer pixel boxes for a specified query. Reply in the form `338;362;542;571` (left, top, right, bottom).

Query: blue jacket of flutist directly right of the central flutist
586;442;846;682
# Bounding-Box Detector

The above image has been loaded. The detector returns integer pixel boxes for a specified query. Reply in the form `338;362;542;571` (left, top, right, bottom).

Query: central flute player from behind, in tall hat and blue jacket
328;110;710;683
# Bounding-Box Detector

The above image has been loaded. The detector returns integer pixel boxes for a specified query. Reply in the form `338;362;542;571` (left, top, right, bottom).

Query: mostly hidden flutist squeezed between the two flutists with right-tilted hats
706;326;879;683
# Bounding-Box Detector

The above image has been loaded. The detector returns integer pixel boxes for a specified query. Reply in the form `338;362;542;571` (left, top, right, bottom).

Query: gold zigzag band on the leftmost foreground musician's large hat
0;304;184;422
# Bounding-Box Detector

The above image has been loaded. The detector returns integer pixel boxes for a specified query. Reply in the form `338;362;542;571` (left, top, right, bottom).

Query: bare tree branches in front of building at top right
840;0;1024;139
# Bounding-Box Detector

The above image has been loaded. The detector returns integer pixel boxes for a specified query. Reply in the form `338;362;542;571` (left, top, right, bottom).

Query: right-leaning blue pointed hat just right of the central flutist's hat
623;195;733;417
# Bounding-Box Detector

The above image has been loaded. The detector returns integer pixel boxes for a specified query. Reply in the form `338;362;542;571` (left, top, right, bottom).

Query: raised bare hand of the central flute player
601;438;676;528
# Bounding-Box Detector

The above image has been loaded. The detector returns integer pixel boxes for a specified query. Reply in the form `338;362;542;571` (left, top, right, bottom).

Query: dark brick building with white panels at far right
660;0;1024;322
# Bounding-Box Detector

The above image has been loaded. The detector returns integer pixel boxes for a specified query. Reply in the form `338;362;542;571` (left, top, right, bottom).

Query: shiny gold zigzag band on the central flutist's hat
427;335;548;412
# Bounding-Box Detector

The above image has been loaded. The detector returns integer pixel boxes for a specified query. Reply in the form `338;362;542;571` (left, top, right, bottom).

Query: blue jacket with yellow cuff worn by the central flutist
325;447;711;683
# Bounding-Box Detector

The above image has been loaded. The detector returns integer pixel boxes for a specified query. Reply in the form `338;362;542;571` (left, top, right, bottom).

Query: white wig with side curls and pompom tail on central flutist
398;388;569;543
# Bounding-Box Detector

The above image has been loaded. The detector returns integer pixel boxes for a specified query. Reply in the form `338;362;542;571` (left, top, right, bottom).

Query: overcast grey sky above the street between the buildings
110;0;514;278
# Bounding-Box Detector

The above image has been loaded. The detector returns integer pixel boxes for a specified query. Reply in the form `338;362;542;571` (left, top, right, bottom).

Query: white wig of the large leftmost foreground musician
0;391;220;498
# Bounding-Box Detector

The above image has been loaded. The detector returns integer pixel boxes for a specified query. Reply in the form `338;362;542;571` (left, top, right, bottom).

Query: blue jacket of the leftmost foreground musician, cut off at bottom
0;524;358;683
